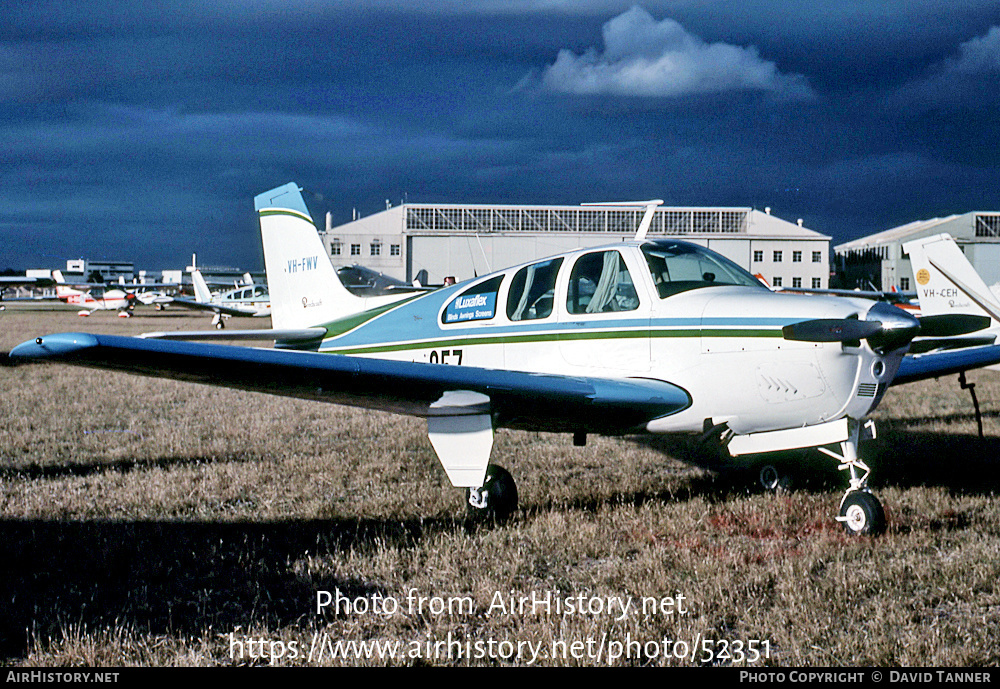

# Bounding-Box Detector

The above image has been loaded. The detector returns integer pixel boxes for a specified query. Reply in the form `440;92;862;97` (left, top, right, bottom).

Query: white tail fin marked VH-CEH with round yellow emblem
903;234;1000;325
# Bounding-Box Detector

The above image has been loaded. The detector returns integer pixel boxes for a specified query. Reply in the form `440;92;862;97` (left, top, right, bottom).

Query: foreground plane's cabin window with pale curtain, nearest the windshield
566;251;639;313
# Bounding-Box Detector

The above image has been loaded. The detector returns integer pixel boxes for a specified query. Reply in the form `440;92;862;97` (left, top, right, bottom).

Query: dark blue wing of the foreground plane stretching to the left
10;333;691;435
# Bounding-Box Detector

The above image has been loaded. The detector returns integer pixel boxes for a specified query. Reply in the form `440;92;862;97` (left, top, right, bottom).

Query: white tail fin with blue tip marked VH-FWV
254;183;369;329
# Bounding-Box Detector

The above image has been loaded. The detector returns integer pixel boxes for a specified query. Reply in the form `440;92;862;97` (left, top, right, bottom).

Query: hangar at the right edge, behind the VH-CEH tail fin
834;211;1000;292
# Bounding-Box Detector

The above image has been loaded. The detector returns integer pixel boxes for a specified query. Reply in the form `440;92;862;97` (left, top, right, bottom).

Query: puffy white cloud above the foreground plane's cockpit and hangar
541;6;813;98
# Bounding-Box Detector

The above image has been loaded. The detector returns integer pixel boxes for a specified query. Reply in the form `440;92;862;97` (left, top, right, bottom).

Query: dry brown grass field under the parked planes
0;304;1000;667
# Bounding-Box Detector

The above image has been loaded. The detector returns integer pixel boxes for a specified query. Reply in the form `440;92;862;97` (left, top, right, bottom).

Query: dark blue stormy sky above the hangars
0;0;1000;269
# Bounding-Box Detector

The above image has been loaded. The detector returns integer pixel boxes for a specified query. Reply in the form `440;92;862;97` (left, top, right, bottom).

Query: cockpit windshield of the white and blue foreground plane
642;240;767;299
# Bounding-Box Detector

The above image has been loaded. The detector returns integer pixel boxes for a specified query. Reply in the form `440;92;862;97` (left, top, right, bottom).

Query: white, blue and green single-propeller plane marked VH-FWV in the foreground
10;184;1000;534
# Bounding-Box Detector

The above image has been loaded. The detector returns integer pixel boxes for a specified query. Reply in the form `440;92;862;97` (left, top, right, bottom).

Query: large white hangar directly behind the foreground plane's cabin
320;203;830;288
